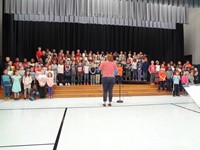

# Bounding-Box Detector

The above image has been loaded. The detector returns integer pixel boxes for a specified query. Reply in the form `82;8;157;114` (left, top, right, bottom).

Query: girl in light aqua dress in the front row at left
12;70;21;100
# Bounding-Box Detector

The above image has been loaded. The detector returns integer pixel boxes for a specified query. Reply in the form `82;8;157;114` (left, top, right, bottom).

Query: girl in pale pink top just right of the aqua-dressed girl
22;71;32;99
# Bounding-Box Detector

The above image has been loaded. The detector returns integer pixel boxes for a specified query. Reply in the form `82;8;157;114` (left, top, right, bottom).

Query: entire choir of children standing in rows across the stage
1;47;198;100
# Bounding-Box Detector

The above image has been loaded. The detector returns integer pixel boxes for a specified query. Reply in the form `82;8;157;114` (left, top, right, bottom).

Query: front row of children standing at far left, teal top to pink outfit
1;69;54;100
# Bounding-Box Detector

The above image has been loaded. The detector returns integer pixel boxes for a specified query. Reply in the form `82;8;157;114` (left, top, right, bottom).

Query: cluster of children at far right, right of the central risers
149;61;199;96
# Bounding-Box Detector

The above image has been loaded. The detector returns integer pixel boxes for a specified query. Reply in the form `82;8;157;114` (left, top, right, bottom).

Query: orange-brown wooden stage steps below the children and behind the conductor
0;84;171;98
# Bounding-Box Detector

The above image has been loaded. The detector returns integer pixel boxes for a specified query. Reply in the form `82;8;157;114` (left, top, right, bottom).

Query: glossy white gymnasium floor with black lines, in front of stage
0;96;200;150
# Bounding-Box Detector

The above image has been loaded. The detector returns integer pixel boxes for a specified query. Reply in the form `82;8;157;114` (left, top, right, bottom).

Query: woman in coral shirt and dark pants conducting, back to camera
99;55;117;107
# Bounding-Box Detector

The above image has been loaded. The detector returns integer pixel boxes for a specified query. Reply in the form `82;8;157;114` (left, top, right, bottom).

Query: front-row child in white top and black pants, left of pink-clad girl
38;69;47;98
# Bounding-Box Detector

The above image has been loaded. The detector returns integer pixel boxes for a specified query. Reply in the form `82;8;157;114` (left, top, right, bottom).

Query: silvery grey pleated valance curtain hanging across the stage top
4;0;189;29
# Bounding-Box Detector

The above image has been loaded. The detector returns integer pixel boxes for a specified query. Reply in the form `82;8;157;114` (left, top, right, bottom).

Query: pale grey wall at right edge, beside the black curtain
184;8;200;64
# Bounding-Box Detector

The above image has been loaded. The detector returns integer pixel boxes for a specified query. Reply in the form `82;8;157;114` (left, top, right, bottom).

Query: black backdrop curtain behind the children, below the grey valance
3;14;184;61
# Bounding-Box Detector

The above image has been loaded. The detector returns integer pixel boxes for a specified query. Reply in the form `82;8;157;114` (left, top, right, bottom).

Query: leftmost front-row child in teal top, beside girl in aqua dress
1;69;12;100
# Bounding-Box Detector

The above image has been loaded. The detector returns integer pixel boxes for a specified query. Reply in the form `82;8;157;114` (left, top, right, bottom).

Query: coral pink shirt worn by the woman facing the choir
99;61;117;77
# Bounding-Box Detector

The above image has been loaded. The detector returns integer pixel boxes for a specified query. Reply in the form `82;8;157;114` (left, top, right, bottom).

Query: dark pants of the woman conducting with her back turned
102;77;115;102
